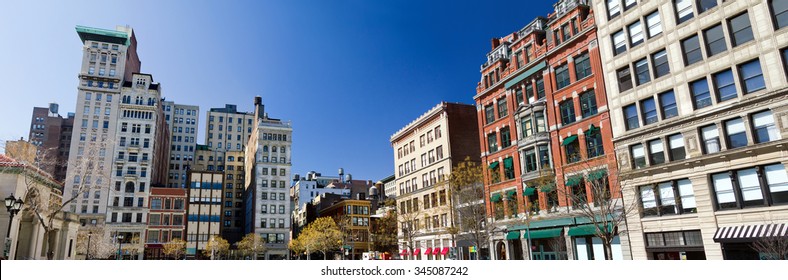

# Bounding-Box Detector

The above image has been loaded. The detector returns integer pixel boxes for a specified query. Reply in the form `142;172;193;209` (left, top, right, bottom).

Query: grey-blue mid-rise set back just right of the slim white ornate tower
162;101;200;188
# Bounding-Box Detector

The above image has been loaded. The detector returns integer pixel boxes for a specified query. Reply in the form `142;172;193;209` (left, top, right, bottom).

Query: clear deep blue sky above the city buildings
0;0;554;180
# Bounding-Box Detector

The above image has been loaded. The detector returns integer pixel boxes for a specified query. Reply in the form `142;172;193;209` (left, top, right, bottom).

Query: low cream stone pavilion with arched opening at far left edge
0;147;79;260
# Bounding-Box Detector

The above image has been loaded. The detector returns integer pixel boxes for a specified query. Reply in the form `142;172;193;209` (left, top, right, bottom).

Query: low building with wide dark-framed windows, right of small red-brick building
186;170;224;259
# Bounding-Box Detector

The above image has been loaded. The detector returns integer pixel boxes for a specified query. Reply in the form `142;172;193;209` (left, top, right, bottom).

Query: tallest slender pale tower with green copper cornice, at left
63;26;142;229
